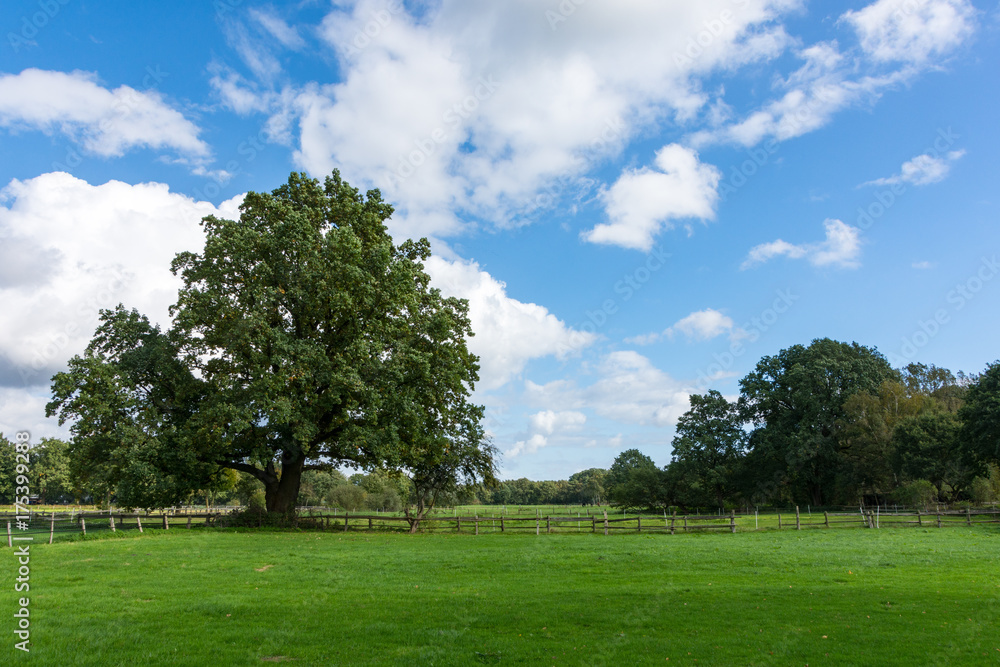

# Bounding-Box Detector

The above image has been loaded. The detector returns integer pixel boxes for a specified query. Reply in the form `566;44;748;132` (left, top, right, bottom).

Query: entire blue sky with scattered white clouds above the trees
0;0;1000;479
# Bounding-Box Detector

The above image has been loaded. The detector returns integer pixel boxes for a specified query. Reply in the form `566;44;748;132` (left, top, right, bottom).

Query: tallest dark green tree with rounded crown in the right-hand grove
740;338;898;505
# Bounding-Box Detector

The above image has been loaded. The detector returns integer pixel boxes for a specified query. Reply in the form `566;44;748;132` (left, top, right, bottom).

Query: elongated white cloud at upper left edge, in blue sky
0;69;209;161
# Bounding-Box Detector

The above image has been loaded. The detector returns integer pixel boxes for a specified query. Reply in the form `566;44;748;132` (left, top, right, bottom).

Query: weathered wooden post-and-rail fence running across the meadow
0;508;1000;546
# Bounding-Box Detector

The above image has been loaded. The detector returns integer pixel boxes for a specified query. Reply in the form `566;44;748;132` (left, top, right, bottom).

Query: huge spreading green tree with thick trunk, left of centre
47;172;496;513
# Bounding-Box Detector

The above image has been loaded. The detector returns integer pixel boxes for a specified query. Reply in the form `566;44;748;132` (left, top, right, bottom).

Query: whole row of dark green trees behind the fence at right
607;339;1000;508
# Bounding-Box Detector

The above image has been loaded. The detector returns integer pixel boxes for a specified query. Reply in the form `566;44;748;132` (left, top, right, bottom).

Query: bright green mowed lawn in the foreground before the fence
7;527;1000;666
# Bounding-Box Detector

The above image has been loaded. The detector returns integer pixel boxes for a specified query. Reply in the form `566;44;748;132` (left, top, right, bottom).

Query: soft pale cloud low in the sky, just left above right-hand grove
525;350;691;426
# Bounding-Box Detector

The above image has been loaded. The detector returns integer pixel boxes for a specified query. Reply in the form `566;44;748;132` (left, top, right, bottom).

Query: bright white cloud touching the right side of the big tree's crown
426;256;597;389
